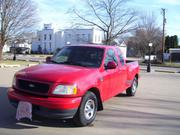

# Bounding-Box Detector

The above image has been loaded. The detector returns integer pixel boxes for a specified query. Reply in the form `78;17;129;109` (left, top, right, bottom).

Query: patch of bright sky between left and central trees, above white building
34;0;75;30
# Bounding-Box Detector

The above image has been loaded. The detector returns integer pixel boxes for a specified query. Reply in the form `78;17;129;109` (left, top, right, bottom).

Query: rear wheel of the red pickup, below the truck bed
126;77;138;96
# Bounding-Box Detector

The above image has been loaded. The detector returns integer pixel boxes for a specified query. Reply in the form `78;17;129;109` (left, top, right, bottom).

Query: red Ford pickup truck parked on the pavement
8;45;139;126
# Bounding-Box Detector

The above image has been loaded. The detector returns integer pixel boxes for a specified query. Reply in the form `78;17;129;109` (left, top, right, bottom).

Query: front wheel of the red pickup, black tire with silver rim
73;91;97;126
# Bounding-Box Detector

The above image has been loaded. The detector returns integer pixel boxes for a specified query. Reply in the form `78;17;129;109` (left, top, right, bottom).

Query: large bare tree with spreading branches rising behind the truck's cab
73;0;136;44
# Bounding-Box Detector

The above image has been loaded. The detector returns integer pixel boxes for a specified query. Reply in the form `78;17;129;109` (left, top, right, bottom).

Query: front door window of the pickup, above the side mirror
104;49;118;67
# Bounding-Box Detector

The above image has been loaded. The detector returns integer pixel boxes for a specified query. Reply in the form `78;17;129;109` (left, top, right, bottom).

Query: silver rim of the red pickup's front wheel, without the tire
84;99;95;120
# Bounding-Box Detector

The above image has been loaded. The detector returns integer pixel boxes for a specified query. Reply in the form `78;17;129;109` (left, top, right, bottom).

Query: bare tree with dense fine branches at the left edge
0;0;37;60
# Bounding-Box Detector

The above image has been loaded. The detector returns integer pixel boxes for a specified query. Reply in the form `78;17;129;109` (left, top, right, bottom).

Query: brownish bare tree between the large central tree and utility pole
128;13;162;56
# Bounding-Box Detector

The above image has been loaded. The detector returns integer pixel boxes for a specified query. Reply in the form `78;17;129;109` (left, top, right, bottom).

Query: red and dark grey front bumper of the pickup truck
8;88;81;118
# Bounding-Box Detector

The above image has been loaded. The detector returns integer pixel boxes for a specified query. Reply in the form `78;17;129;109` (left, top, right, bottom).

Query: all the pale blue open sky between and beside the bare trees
33;0;180;37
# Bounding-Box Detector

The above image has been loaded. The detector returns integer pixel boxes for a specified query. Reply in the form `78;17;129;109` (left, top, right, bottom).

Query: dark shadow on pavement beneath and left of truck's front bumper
0;87;77;129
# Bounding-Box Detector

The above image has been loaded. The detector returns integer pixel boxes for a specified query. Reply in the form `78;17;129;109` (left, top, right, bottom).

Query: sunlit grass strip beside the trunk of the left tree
0;60;39;66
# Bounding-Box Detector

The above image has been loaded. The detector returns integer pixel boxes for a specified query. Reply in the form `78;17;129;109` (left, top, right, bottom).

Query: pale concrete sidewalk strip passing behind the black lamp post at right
140;65;180;73
